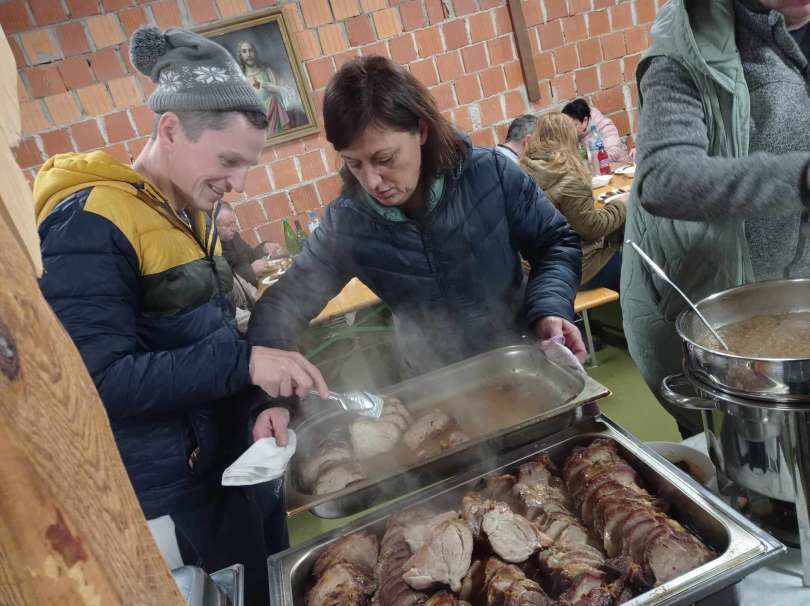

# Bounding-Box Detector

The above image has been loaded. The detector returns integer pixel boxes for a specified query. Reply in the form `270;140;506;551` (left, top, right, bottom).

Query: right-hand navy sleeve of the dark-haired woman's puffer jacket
497;157;582;326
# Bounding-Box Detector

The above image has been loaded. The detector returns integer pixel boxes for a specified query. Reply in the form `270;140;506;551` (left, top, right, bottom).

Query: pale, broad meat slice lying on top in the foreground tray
402;518;473;591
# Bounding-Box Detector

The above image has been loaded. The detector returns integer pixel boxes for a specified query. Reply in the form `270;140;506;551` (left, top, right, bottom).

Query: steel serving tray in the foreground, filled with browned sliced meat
268;416;785;606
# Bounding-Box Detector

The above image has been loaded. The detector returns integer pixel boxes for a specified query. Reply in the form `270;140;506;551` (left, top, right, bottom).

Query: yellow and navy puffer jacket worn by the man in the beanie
34;152;250;518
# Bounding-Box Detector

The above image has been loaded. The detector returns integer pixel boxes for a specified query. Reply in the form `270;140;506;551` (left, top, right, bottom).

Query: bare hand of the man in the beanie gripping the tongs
250;347;329;400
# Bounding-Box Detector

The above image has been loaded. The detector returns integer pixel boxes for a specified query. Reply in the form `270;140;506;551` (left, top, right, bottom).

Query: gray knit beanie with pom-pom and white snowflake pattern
130;26;267;114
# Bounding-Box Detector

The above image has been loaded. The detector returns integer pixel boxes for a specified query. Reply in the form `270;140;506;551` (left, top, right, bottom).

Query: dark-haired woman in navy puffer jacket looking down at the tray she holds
248;57;585;376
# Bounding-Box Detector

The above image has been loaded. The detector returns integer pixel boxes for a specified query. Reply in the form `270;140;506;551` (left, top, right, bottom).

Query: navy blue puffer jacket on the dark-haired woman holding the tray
248;142;581;375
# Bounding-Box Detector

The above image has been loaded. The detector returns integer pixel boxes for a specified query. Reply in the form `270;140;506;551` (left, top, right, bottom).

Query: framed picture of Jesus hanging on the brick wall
196;8;319;145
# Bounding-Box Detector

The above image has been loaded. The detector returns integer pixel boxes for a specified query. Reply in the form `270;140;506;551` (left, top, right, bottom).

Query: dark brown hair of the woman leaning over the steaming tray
323;56;467;195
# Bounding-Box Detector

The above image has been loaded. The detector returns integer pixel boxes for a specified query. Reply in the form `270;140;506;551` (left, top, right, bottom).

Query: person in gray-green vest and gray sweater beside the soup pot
621;0;810;435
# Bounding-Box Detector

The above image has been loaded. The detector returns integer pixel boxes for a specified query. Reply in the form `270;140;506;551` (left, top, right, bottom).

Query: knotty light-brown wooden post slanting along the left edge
0;23;184;606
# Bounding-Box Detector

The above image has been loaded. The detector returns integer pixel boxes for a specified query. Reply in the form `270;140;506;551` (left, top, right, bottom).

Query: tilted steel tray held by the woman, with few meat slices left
285;345;609;518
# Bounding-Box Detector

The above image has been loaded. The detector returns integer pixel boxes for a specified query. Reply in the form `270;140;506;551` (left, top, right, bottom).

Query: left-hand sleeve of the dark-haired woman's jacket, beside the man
247;208;352;350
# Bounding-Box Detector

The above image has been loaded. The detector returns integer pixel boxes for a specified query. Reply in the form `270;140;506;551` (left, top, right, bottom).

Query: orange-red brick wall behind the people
0;0;663;247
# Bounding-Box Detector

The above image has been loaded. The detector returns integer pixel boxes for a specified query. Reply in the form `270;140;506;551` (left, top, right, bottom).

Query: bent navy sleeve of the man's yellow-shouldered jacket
40;205;250;422
